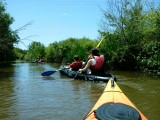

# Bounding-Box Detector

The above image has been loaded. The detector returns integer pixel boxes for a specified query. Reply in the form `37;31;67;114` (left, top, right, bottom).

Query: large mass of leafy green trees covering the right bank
99;0;160;70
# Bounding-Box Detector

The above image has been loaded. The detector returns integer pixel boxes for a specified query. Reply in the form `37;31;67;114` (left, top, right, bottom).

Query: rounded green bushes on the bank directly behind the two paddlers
46;38;97;64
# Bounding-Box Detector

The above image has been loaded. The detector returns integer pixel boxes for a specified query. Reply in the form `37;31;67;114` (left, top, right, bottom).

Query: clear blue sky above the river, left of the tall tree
5;0;106;49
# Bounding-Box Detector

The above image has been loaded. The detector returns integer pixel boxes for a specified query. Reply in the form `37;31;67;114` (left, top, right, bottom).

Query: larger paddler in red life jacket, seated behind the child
78;48;105;75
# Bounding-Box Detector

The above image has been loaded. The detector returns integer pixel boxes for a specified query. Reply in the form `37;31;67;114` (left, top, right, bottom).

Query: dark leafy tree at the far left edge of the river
0;1;19;61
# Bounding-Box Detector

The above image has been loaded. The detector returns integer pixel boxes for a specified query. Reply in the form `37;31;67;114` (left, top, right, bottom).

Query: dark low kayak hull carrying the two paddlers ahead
59;66;116;82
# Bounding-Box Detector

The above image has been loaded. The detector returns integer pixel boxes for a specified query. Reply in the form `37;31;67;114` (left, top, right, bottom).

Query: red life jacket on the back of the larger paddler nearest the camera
90;55;105;74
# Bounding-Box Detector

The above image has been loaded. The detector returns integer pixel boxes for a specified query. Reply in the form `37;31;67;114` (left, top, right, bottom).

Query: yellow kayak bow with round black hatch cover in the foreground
84;79;148;120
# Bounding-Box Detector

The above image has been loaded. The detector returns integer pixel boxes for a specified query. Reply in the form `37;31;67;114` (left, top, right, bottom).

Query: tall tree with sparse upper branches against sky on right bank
102;0;144;69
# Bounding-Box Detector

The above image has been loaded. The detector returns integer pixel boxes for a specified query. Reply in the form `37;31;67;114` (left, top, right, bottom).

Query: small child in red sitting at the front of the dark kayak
69;55;82;71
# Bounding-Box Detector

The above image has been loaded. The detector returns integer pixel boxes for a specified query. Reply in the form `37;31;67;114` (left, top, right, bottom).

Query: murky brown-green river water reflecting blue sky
0;63;160;120
